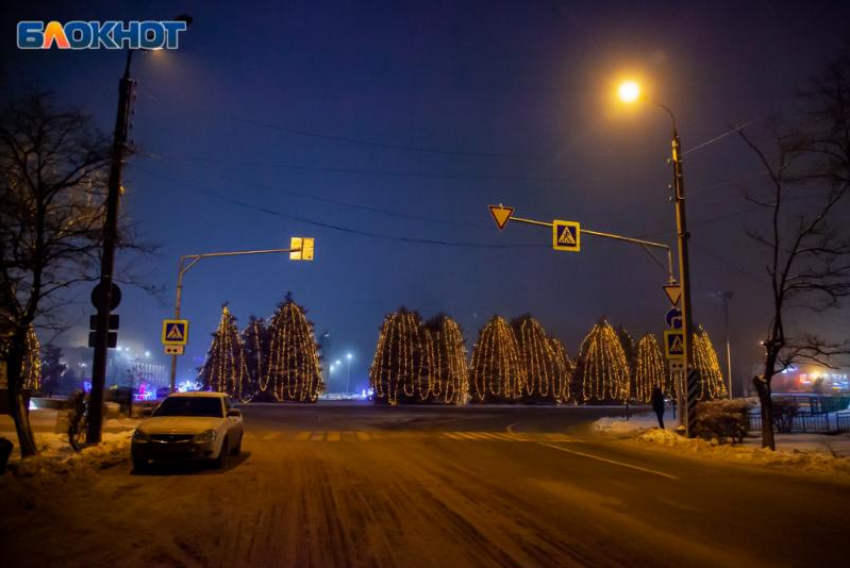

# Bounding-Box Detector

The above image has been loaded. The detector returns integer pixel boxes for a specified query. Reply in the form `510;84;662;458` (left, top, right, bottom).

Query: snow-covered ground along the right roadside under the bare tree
594;413;850;476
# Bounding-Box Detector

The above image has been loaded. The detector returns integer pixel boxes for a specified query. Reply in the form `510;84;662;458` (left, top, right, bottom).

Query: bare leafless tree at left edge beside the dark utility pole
0;94;109;456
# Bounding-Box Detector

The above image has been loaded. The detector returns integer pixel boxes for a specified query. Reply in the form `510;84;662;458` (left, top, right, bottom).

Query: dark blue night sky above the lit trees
0;0;850;390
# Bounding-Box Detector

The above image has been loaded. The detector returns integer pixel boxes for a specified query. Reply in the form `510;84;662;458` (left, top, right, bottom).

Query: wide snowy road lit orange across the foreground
0;403;850;568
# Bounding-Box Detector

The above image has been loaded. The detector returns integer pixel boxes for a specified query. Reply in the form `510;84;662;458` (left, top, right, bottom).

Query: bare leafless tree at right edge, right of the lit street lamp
739;57;850;450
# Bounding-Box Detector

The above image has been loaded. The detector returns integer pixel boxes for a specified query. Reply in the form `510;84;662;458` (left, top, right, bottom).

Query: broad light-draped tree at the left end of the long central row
369;307;436;406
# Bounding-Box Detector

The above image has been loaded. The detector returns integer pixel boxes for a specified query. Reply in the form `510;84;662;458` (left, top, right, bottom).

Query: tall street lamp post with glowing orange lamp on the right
618;81;698;437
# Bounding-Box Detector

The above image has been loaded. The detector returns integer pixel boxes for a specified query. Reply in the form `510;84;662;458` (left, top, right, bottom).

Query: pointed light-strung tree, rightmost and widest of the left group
258;292;325;402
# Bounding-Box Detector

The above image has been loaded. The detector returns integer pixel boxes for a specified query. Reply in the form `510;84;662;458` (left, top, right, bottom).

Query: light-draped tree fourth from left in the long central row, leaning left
511;314;569;403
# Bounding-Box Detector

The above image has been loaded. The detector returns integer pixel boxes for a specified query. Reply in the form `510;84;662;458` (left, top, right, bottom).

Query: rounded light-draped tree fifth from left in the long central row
578;319;629;402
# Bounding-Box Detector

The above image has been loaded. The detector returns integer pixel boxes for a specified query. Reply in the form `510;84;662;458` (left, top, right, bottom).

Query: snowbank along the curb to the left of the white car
4;430;133;482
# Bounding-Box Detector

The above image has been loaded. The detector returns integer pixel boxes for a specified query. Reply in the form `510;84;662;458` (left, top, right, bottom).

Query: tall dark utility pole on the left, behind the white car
86;49;134;444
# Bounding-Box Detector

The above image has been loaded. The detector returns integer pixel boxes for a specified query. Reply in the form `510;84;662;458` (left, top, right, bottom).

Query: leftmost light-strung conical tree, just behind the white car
198;304;248;400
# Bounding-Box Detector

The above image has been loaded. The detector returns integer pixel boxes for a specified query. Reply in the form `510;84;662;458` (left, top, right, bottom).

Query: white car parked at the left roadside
131;391;244;471
